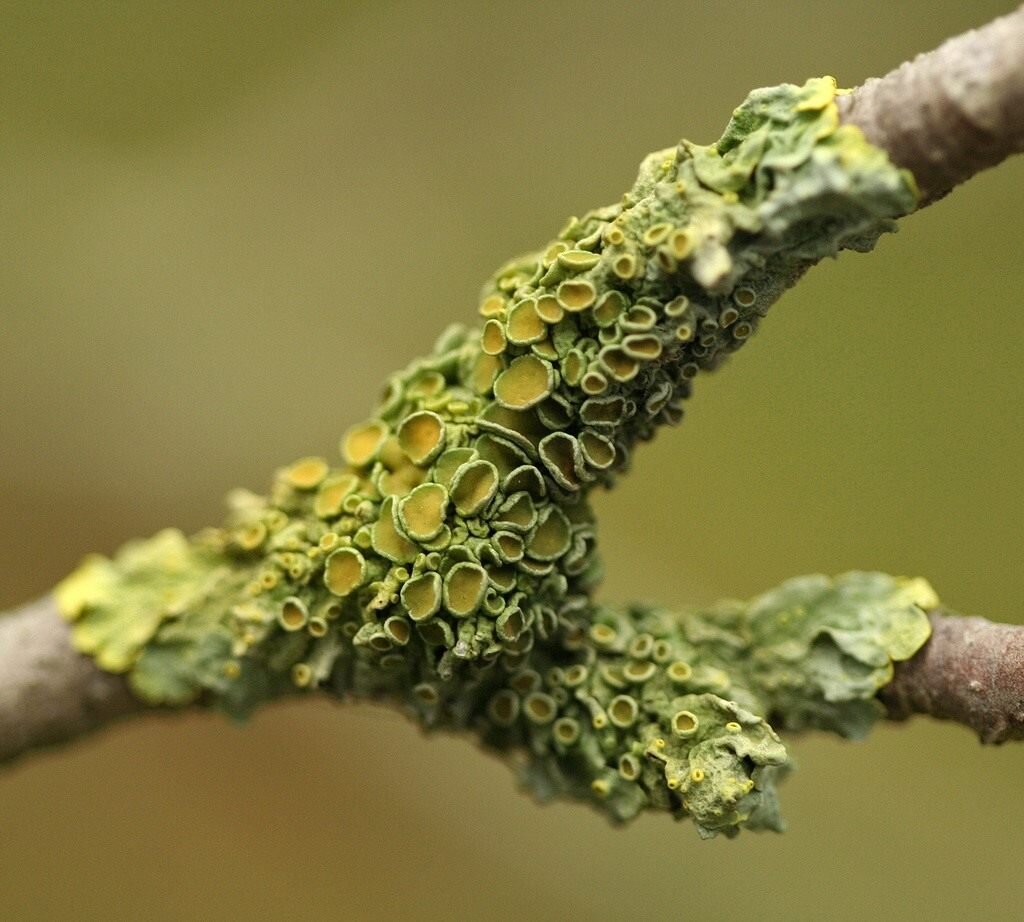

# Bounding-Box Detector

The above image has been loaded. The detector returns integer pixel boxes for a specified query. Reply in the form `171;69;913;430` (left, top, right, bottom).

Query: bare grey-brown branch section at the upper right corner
838;6;1024;206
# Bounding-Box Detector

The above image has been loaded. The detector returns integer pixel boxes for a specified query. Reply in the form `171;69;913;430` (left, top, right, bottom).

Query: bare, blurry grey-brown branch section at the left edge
0;596;142;763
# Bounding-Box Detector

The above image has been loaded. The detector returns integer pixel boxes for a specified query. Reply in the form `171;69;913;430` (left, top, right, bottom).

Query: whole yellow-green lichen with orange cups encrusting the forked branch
57;78;937;836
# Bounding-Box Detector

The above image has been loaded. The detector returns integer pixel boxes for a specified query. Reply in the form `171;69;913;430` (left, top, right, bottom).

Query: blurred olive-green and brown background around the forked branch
0;0;1024;920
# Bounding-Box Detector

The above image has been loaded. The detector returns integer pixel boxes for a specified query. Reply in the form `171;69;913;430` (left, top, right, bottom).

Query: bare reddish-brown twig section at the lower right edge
880;612;1024;743
